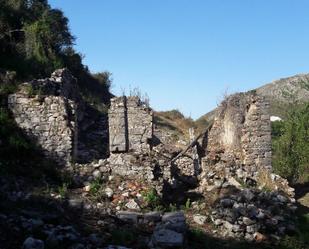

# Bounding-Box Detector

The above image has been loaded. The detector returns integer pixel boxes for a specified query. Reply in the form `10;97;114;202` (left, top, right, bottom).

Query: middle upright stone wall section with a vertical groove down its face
109;96;153;153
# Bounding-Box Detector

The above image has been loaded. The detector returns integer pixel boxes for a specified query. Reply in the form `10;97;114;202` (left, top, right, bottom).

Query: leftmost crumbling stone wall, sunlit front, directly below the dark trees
8;69;78;165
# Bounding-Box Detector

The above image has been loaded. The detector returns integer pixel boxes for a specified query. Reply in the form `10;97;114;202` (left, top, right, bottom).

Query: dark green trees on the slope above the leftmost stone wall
0;0;111;106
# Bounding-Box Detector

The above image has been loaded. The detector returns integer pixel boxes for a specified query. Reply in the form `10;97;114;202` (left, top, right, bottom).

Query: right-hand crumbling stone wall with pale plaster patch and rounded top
202;92;271;184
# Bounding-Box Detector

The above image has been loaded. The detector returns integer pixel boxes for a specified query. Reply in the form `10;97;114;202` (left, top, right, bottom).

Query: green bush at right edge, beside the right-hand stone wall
273;104;309;183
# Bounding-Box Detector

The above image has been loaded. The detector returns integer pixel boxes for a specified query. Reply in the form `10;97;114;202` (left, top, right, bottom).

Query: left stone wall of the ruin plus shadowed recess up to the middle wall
8;69;108;166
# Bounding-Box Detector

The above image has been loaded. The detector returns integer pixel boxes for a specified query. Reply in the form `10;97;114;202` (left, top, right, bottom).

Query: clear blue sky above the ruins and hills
49;0;309;118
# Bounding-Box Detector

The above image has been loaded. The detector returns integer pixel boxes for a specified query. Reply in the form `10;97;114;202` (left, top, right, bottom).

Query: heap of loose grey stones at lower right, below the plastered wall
211;189;297;241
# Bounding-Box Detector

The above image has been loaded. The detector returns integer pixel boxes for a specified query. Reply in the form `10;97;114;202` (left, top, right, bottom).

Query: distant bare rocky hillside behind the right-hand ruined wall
196;74;309;124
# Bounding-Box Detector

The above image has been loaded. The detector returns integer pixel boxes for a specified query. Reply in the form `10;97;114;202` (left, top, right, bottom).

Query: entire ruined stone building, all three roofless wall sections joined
8;69;271;189
